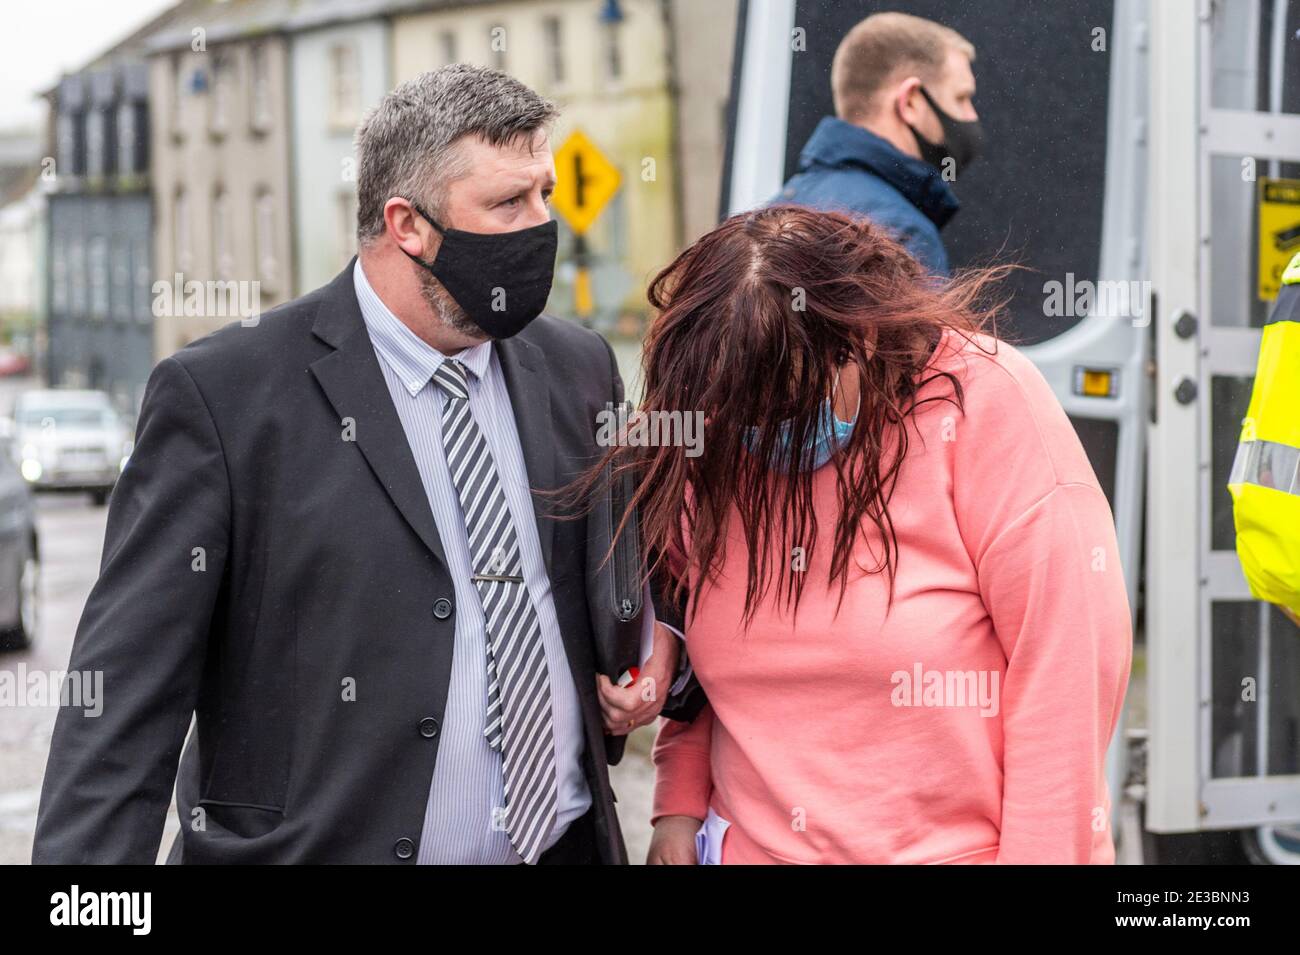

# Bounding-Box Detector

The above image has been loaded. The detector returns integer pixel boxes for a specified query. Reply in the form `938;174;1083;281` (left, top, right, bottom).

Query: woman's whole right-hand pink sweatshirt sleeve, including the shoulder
948;342;1132;863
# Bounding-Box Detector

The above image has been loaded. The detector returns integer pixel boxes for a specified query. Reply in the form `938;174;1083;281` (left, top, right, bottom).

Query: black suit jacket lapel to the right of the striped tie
493;337;555;574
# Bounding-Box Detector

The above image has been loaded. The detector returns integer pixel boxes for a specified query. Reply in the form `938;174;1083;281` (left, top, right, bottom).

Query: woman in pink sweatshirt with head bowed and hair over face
590;207;1131;864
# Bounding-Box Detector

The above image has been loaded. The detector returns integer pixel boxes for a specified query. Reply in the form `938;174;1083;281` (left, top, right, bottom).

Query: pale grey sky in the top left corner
0;0;174;130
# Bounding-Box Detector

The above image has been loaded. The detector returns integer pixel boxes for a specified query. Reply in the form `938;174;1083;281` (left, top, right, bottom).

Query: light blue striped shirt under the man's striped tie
352;259;590;865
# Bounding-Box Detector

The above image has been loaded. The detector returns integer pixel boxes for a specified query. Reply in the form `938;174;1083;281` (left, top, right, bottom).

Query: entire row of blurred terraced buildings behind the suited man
35;0;737;382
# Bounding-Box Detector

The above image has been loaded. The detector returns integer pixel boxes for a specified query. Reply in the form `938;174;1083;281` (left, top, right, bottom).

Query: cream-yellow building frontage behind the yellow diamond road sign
393;0;736;339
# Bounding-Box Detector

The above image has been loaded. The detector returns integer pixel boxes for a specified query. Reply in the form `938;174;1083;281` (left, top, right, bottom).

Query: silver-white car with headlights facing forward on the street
13;390;131;507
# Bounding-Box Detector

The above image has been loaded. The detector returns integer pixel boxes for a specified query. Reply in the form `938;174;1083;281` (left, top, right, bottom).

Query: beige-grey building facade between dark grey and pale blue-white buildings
148;3;296;357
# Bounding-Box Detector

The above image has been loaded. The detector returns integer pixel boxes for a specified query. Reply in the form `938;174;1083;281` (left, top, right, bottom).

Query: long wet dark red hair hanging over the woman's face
579;205;1013;621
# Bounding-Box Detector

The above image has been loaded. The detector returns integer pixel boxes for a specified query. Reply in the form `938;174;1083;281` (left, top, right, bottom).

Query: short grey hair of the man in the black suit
355;64;558;244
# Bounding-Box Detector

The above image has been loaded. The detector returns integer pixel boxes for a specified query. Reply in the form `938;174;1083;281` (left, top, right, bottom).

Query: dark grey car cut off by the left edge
0;446;40;650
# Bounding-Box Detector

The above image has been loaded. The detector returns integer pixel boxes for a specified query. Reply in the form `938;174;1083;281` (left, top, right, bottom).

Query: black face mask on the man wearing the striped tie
402;203;558;338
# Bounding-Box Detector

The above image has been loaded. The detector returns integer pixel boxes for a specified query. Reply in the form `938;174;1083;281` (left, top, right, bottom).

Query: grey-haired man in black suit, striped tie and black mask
33;65;679;863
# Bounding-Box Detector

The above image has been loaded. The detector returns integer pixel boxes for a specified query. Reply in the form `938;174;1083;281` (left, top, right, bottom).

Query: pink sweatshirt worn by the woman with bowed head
654;333;1132;864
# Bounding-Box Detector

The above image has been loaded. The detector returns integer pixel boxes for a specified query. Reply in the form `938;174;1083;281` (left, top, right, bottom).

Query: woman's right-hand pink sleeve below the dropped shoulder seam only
978;483;1132;864
